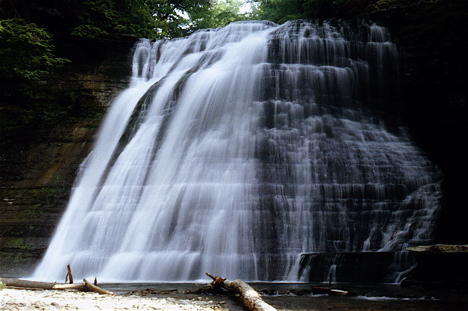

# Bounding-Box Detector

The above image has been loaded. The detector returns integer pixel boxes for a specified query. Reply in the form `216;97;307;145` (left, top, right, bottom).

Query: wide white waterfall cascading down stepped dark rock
34;21;441;281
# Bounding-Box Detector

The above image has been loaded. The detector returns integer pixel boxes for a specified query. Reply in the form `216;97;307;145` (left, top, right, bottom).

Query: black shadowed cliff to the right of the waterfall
369;0;468;244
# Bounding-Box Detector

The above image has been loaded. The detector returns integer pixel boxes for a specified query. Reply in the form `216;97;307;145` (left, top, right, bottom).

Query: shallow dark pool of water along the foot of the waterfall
99;283;468;311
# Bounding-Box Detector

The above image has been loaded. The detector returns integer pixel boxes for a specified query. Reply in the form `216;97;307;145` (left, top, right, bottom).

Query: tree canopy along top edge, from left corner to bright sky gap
0;0;252;38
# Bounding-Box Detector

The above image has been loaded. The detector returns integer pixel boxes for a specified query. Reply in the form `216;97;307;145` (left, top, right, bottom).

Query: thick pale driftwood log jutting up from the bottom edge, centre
206;273;276;311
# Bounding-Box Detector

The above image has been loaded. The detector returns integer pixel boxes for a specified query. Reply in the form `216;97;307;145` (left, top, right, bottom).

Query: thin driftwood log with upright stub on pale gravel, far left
0;278;114;295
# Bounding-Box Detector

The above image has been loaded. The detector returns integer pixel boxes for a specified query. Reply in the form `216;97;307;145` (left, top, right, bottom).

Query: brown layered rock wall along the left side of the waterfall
0;34;134;277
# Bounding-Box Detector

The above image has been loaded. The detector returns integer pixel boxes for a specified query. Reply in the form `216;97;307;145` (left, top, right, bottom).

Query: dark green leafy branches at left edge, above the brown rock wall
0;18;67;145
